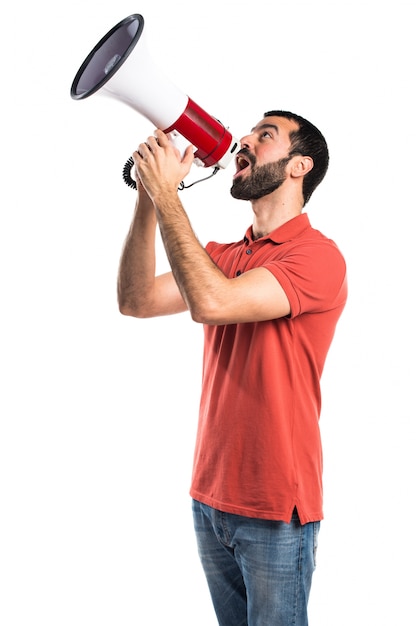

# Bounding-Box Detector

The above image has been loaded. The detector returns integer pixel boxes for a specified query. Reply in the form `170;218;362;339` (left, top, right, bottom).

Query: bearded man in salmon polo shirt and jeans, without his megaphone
118;111;347;626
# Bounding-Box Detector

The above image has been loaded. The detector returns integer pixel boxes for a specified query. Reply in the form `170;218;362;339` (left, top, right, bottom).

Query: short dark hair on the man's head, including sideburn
264;111;329;204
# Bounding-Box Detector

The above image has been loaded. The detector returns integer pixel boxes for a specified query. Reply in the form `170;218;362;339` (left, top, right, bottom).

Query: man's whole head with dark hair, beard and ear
231;110;329;204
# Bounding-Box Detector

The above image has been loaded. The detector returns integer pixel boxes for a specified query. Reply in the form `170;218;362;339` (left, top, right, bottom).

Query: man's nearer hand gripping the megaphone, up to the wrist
133;129;194;201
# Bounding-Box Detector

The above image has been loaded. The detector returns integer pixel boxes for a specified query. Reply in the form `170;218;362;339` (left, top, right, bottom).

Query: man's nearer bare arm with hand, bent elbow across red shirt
133;126;290;324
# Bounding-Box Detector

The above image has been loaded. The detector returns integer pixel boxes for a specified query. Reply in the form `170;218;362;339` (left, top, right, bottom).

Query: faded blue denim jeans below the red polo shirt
193;500;320;626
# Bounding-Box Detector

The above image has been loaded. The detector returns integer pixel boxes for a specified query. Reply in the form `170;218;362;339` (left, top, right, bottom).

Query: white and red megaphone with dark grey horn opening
71;13;239;187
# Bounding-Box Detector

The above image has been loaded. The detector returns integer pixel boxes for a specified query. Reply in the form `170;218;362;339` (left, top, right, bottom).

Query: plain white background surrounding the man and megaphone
0;0;416;626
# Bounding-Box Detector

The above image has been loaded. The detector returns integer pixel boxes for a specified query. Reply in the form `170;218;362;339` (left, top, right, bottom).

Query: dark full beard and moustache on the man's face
230;150;290;200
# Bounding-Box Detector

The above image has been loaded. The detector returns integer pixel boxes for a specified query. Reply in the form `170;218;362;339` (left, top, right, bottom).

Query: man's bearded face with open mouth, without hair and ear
230;116;297;200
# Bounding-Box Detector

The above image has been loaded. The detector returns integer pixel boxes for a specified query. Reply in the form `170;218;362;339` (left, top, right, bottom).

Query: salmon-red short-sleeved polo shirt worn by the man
190;213;347;524
